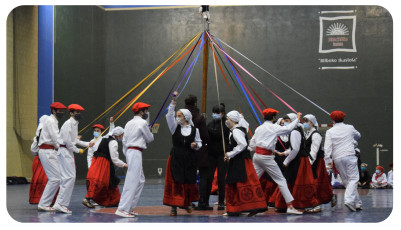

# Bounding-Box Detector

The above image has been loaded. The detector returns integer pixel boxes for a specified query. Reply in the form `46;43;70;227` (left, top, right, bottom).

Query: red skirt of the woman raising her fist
163;156;199;209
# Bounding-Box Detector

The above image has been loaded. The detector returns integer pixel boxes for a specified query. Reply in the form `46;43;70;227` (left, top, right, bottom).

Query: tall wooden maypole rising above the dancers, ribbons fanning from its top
201;6;209;114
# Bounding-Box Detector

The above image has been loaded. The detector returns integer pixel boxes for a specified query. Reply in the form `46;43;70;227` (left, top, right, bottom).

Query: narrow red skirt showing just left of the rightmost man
315;158;333;204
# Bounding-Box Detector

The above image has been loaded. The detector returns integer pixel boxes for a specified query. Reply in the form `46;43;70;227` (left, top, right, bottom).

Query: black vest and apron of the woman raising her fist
170;125;197;184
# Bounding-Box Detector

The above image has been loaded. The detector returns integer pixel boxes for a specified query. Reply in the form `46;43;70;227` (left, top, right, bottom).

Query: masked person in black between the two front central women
206;103;230;210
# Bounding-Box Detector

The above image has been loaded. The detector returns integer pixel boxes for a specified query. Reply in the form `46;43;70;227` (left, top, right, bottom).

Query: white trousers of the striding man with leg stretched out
253;153;294;203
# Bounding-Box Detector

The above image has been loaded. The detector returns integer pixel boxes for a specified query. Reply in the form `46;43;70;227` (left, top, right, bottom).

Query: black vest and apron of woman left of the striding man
226;127;251;184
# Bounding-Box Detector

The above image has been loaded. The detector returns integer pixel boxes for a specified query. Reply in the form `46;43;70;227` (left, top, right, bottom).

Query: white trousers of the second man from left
56;147;76;207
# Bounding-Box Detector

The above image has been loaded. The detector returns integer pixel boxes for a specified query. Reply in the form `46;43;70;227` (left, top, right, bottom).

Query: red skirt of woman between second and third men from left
86;157;121;207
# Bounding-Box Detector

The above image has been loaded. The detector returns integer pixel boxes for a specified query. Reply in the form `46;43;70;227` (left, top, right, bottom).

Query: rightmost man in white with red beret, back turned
324;111;362;212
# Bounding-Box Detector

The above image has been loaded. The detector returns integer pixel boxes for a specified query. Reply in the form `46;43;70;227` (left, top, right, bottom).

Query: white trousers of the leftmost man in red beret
39;149;61;206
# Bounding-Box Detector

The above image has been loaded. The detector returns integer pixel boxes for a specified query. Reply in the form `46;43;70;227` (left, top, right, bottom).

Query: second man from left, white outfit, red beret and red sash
53;104;93;214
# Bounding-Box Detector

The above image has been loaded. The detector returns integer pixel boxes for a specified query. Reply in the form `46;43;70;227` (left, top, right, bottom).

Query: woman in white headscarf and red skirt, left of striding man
224;110;267;216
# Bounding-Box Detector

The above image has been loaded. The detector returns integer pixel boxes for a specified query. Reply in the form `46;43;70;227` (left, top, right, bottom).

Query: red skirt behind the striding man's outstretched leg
275;157;319;209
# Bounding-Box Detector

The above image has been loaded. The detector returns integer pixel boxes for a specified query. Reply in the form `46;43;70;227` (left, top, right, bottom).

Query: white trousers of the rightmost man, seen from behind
334;155;362;206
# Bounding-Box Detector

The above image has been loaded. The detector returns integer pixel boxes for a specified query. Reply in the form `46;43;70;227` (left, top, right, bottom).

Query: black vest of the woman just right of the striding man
284;126;309;185
